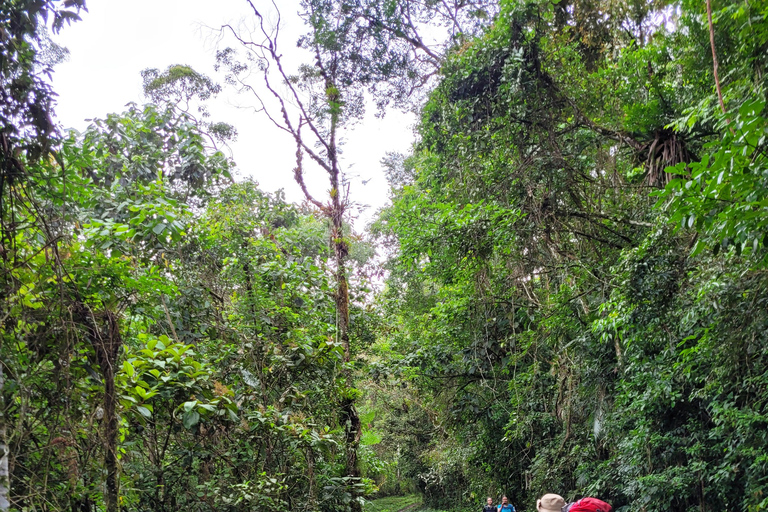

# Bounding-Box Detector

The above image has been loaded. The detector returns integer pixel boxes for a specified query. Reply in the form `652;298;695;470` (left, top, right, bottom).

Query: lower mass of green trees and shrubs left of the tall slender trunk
3;94;378;511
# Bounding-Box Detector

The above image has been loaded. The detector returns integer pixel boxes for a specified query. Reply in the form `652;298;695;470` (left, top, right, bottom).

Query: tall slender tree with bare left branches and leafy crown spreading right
213;0;497;500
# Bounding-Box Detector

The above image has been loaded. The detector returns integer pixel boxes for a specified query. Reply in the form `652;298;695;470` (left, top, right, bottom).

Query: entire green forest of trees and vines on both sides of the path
0;0;768;512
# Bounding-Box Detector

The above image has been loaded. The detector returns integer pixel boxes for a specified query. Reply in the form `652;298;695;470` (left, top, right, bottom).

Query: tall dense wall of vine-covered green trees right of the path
364;2;768;510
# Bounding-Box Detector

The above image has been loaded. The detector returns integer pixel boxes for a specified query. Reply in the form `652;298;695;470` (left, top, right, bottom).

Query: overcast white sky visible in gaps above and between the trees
53;0;415;224
